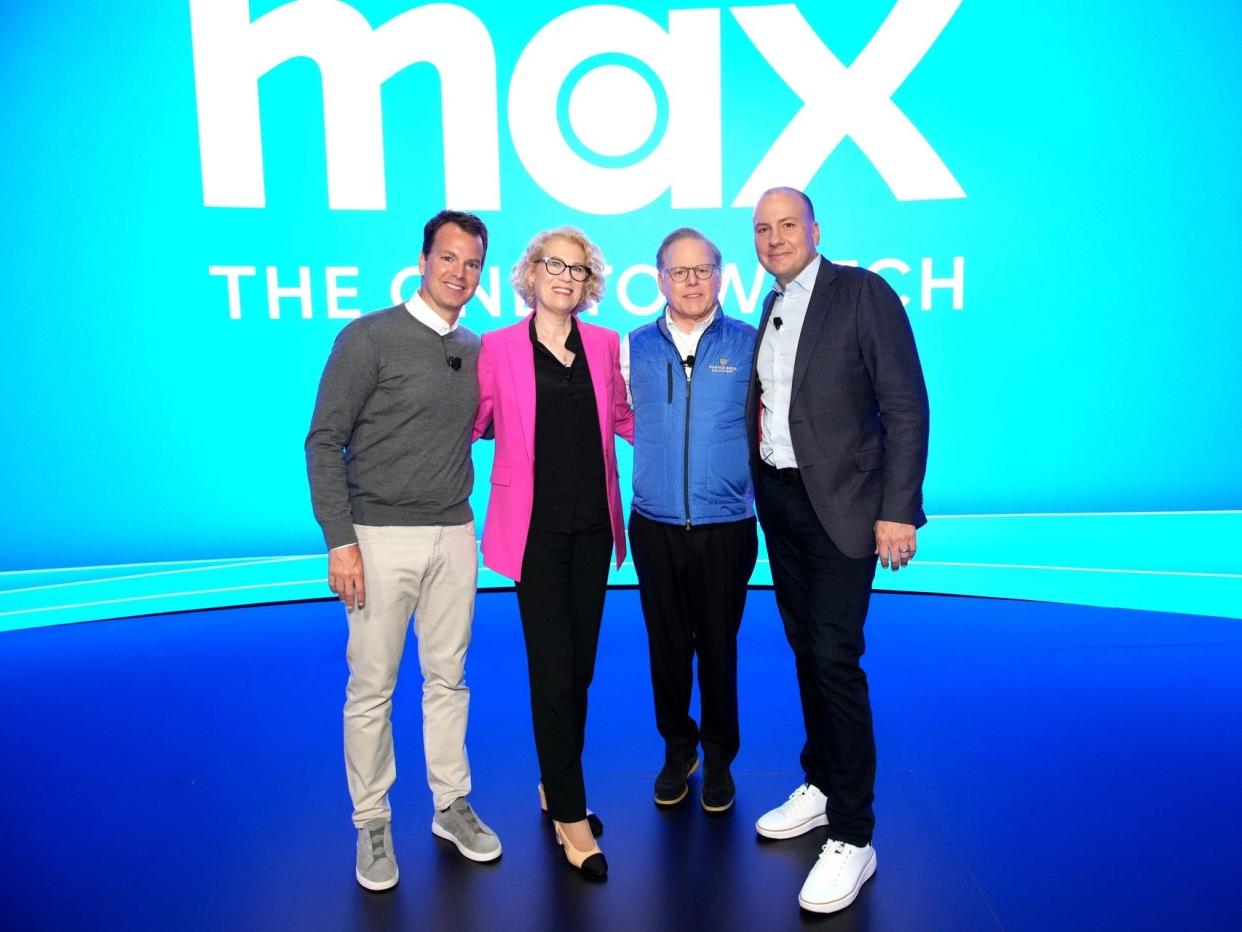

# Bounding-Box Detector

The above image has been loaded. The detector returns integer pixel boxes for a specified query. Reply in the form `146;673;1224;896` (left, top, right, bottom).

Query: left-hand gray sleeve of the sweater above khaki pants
306;321;379;551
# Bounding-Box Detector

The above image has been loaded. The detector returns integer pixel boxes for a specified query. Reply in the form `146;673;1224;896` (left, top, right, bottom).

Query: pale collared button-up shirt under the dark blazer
756;254;822;470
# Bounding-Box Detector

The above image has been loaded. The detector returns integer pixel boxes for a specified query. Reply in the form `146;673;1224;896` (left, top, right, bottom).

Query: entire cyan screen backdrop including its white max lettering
0;0;1242;630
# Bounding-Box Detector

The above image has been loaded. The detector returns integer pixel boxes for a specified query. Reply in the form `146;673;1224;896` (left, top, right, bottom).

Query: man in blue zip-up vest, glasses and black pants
621;227;758;813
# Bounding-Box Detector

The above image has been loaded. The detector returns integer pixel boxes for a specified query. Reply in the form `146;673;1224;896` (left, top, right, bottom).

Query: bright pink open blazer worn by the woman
474;316;633;580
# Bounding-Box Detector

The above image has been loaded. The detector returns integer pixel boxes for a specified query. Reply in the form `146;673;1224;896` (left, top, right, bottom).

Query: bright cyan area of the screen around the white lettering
0;0;1242;629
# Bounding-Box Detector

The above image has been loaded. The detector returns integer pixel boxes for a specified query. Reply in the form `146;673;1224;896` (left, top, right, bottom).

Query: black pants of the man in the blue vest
630;512;759;768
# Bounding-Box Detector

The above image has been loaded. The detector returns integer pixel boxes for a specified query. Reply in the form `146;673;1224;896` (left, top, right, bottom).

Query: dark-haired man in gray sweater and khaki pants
306;210;501;890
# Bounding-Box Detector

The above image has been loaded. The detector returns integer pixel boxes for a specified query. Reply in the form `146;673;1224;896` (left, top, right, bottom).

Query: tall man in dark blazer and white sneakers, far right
746;188;928;912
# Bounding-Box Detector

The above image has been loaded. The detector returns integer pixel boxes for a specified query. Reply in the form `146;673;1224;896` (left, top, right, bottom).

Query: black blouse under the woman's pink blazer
530;314;609;533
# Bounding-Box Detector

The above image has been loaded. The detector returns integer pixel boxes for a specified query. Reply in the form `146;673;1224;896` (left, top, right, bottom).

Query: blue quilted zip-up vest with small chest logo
630;314;756;527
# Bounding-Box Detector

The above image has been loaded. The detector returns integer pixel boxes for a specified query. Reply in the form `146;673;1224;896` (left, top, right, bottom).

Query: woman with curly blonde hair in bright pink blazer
474;226;633;880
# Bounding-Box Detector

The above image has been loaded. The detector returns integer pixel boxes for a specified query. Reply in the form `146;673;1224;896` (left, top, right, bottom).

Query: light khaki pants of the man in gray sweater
345;522;478;826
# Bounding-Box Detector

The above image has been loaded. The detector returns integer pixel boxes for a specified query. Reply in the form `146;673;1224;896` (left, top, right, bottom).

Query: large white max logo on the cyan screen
190;0;965;214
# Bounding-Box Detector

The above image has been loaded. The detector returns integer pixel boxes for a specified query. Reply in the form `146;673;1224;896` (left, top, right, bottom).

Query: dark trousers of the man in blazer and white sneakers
755;466;876;845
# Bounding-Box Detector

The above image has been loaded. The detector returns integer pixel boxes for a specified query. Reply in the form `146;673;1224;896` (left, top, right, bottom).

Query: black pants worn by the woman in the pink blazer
517;527;612;821
